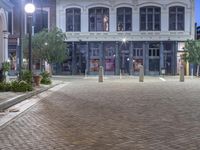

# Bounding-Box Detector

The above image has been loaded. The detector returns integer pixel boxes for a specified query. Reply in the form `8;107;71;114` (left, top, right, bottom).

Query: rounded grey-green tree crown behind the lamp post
23;28;68;64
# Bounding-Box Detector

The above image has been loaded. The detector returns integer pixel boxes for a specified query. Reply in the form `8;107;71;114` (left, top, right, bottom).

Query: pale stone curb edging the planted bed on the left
0;83;60;112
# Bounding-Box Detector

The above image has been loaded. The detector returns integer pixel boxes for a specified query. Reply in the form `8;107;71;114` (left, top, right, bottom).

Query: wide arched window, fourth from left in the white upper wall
140;6;161;31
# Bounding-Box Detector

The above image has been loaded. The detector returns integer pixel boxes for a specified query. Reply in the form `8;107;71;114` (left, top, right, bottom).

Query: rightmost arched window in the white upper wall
169;6;185;30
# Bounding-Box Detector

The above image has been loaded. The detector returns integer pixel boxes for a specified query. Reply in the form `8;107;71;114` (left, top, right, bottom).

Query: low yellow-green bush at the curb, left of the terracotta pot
11;80;33;92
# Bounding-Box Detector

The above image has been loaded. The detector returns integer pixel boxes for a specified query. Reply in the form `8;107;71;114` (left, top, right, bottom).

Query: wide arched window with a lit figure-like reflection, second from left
89;7;109;31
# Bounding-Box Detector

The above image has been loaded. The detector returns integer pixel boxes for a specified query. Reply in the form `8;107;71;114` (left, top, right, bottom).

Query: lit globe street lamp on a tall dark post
24;3;35;72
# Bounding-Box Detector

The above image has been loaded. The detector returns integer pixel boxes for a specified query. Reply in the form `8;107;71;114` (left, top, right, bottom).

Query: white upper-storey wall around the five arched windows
56;0;195;41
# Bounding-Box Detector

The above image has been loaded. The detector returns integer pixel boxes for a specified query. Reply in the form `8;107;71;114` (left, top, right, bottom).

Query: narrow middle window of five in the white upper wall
117;7;132;31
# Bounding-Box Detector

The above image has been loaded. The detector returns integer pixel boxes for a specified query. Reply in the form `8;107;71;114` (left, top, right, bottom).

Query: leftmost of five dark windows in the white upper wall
66;8;81;32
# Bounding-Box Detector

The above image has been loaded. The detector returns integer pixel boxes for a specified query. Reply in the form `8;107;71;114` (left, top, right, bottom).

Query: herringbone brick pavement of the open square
0;79;200;150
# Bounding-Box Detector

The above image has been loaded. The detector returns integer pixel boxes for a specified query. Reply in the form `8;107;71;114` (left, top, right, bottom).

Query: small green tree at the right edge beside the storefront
183;40;200;76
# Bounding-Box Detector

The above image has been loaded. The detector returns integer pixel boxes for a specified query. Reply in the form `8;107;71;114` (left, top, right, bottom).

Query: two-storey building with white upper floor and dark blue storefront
56;0;195;75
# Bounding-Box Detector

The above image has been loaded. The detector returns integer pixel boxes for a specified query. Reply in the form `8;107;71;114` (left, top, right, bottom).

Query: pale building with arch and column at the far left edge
0;0;13;67
